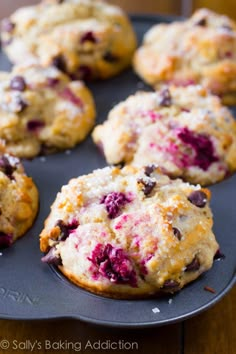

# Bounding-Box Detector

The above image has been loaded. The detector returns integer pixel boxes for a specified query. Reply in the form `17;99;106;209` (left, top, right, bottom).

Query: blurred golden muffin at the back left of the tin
1;0;136;79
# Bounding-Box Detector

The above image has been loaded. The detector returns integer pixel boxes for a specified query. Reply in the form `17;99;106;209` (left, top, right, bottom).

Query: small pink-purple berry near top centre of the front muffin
101;192;131;219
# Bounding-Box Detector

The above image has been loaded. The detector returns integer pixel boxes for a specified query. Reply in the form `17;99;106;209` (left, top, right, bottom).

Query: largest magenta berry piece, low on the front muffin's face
88;243;137;287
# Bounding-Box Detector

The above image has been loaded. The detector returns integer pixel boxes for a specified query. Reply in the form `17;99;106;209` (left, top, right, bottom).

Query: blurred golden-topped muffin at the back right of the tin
133;9;236;105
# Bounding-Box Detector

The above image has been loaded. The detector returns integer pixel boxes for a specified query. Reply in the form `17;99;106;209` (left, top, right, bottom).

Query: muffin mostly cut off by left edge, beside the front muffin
0;151;38;248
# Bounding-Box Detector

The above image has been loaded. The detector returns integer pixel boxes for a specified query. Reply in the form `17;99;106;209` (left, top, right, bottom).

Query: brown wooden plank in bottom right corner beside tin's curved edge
184;287;236;354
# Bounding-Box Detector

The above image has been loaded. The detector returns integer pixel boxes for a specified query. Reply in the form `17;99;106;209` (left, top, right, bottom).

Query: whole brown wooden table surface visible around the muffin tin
0;0;236;354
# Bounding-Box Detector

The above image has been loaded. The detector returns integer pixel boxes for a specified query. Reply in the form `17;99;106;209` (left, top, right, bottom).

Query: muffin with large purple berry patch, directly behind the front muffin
92;85;236;185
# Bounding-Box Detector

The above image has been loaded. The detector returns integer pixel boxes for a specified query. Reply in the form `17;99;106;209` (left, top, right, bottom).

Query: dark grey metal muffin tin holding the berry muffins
0;16;236;327
